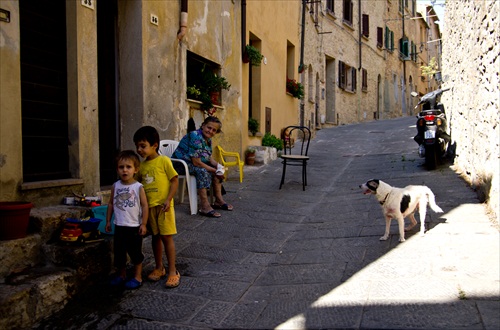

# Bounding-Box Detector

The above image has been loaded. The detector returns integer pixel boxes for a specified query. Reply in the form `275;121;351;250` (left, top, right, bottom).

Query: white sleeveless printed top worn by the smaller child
113;181;142;227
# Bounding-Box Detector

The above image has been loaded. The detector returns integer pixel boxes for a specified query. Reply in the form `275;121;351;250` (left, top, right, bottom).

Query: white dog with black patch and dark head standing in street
359;179;443;242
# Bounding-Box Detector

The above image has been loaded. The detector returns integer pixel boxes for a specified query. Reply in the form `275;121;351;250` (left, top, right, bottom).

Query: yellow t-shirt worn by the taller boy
139;155;178;207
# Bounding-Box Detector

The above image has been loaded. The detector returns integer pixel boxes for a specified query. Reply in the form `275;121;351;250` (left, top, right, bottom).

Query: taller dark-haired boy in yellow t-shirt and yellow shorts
134;126;181;288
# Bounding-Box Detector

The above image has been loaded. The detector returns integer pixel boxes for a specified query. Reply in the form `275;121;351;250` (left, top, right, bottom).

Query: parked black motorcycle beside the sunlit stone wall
411;88;451;170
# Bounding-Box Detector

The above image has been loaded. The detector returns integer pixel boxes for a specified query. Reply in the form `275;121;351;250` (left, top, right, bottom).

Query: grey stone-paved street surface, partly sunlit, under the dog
38;117;500;329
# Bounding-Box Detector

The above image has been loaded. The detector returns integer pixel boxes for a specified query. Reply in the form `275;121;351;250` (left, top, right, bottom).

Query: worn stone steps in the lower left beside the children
0;206;112;329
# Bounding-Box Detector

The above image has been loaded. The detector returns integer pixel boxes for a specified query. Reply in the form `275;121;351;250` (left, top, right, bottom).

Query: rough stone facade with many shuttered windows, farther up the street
301;0;432;127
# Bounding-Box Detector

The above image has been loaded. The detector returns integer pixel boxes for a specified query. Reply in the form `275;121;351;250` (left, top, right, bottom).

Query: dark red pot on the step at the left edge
0;202;33;241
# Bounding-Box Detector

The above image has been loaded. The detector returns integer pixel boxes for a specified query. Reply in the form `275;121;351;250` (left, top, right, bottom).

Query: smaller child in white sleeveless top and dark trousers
105;150;148;289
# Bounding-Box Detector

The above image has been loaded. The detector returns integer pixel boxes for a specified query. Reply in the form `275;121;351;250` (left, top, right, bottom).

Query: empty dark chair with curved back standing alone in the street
280;126;311;190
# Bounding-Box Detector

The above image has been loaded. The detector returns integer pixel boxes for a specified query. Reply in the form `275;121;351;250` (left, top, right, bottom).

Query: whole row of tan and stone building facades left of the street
0;0;440;206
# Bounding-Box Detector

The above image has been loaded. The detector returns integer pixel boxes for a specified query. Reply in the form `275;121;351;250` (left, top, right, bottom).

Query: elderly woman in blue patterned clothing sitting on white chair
172;117;233;218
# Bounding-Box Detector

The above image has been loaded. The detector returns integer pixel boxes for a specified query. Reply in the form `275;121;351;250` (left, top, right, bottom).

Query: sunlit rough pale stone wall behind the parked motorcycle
441;1;500;219
